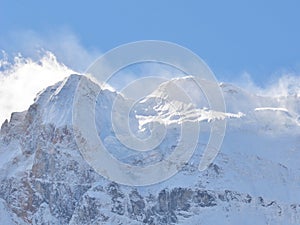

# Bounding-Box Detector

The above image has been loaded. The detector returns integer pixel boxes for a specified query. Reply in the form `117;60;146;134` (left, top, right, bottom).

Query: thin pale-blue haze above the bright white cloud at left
0;28;100;72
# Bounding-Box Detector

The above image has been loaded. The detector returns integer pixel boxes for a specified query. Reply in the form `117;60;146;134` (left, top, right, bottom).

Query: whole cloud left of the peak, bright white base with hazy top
0;28;101;124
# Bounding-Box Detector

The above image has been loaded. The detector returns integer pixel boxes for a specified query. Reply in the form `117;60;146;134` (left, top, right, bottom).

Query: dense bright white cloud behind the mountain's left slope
0;52;74;124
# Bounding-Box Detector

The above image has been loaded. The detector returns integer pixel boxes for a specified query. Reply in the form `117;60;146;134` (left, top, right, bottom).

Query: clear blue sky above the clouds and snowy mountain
0;0;300;86
